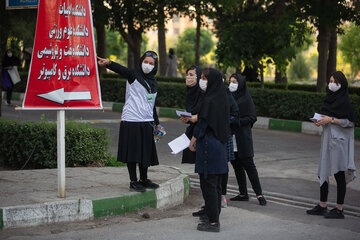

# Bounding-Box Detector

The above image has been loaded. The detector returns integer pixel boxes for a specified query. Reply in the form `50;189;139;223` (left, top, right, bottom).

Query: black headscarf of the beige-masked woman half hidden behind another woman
185;66;204;114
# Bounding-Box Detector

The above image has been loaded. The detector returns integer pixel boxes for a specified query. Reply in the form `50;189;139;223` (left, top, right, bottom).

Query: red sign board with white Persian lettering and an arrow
23;0;102;110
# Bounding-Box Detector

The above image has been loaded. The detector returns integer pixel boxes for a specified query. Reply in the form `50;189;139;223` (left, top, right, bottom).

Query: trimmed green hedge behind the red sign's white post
0;119;111;169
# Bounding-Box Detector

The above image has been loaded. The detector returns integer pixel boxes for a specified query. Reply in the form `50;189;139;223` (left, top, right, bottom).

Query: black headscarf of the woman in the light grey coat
321;71;355;122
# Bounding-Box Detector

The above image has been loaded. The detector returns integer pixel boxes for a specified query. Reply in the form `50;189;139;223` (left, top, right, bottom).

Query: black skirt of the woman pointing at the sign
117;121;159;167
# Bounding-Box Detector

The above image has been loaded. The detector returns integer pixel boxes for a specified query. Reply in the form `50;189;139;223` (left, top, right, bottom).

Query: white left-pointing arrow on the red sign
37;88;91;105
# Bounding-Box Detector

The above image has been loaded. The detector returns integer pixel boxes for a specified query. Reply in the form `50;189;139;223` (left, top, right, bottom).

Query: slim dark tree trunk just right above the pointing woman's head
158;6;166;76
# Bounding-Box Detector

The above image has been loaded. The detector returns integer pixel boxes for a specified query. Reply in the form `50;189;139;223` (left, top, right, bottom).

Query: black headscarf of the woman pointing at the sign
135;51;159;93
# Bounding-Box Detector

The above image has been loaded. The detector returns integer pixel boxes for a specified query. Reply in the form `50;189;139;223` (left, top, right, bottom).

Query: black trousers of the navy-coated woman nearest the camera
200;174;221;223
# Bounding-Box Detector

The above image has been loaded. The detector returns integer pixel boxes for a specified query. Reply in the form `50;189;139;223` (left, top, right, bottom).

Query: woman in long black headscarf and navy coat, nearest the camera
189;68;230;232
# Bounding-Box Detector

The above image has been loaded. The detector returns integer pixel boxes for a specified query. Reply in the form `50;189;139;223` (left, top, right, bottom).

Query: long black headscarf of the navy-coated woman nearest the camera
199;68;230;143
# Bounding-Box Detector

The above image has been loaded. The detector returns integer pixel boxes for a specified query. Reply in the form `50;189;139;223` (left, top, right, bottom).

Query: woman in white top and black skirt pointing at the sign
98;51;160;192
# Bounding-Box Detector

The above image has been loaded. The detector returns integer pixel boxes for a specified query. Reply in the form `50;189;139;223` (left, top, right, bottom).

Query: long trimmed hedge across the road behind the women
5;73;360;126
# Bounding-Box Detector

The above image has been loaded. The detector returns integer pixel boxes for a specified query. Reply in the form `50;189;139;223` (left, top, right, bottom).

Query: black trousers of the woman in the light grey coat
320;171;346;204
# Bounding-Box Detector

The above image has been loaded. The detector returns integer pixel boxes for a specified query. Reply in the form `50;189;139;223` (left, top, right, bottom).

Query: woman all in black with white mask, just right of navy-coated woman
230;74;266;205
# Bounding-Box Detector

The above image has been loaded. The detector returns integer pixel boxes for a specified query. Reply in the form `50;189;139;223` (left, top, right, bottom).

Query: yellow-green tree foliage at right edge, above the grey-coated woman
339;24;360;78
